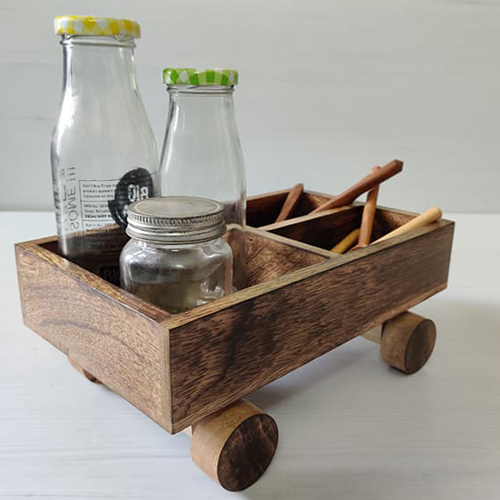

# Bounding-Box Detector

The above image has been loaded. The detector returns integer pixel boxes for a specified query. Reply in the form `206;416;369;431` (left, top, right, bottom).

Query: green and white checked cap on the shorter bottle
163;68;238;87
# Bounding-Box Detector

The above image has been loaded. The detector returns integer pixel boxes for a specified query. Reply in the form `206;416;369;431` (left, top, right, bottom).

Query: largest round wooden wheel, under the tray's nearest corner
191;400;278;491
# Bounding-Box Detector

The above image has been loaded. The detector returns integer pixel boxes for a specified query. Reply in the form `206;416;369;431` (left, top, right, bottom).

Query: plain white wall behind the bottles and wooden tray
0;0;500;212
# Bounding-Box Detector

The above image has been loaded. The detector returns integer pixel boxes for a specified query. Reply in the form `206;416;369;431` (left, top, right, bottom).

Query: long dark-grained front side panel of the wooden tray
170;223;453;432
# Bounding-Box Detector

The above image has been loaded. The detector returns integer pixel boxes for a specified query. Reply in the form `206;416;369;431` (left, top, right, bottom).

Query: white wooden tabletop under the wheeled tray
0;213;500;500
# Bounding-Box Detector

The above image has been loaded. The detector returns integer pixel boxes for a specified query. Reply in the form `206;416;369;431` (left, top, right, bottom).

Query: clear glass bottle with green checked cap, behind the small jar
160;68;246;288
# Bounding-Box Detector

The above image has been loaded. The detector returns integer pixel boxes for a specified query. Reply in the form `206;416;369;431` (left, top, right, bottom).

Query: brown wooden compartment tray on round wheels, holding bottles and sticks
16;190;454;491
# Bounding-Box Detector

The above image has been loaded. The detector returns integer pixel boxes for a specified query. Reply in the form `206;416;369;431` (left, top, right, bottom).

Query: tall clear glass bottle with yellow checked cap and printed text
51;16;158;283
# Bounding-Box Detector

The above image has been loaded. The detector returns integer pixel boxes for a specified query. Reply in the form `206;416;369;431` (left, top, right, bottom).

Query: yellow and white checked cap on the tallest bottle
54;16;141;38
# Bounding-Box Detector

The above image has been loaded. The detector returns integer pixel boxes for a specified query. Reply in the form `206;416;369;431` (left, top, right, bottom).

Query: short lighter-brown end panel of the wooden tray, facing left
16;245;171;431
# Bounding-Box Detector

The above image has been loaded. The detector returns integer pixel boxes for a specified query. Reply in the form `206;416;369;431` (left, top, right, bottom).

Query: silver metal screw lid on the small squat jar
127;196;226;244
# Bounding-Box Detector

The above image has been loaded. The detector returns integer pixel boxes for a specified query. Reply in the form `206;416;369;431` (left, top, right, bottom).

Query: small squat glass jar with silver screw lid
120;196;233;314
